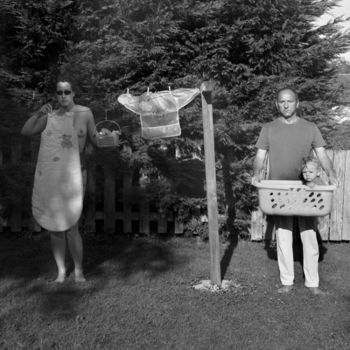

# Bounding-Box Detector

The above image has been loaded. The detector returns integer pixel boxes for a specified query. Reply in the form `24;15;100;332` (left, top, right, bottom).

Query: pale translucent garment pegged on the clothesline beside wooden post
118;88;200;140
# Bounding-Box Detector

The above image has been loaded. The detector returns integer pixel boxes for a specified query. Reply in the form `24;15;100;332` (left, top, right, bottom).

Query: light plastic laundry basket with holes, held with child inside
256;180;336;216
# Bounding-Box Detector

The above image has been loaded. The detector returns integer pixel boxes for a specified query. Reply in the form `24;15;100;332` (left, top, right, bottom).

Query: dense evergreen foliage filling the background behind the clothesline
0;0;350;237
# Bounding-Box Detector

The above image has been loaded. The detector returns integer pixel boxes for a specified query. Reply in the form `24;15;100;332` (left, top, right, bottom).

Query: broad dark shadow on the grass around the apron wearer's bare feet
0;235;186;321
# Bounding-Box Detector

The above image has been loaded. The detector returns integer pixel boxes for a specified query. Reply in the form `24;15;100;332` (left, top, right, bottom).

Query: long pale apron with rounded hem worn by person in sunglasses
32;111;83;231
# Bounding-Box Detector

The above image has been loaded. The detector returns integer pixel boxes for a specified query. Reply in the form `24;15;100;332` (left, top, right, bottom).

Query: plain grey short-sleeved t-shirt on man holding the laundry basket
256;119;326;180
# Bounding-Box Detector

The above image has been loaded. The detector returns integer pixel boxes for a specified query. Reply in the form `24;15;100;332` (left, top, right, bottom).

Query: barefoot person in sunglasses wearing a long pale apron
22;80;95;283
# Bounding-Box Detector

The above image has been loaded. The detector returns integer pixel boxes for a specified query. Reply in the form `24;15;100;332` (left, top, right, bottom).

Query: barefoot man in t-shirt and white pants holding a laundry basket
252;87;337;294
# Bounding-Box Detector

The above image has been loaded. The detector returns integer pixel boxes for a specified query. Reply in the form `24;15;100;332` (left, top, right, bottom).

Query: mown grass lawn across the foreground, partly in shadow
0;234;350;350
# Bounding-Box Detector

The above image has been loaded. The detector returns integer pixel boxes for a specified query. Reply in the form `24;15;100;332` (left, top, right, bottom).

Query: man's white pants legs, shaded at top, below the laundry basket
275;216;319;287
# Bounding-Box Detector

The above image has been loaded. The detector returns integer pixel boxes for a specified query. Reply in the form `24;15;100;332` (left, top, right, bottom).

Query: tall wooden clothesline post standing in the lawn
201;81;221;286
